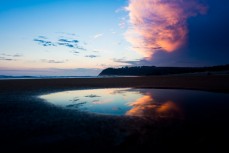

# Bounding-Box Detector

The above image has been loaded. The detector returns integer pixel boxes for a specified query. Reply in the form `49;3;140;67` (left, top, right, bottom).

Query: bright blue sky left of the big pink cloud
0;0;139;75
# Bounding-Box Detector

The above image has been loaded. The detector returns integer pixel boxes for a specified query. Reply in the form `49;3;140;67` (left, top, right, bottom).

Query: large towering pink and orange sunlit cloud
126;0;207;59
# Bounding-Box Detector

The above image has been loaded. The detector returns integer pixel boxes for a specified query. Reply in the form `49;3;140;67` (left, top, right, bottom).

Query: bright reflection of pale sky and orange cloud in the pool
40;88;184;117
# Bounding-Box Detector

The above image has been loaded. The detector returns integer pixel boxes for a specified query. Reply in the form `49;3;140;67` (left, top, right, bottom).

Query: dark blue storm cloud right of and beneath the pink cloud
125;0;229;66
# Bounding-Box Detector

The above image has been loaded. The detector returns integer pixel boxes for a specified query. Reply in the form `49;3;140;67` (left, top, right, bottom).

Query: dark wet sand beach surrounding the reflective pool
0;75;229;153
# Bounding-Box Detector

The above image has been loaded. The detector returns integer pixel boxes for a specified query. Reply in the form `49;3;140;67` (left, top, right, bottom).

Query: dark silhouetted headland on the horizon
99;64;229;76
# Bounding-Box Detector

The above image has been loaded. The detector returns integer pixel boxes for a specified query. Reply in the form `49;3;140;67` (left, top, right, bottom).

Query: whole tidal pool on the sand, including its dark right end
40;88;229;118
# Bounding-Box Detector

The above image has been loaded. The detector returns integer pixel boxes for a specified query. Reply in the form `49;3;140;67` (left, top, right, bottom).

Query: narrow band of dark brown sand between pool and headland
0;75;229;93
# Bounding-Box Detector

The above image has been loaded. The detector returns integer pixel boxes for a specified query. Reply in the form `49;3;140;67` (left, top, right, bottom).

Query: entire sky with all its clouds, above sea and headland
0;0;229;76
